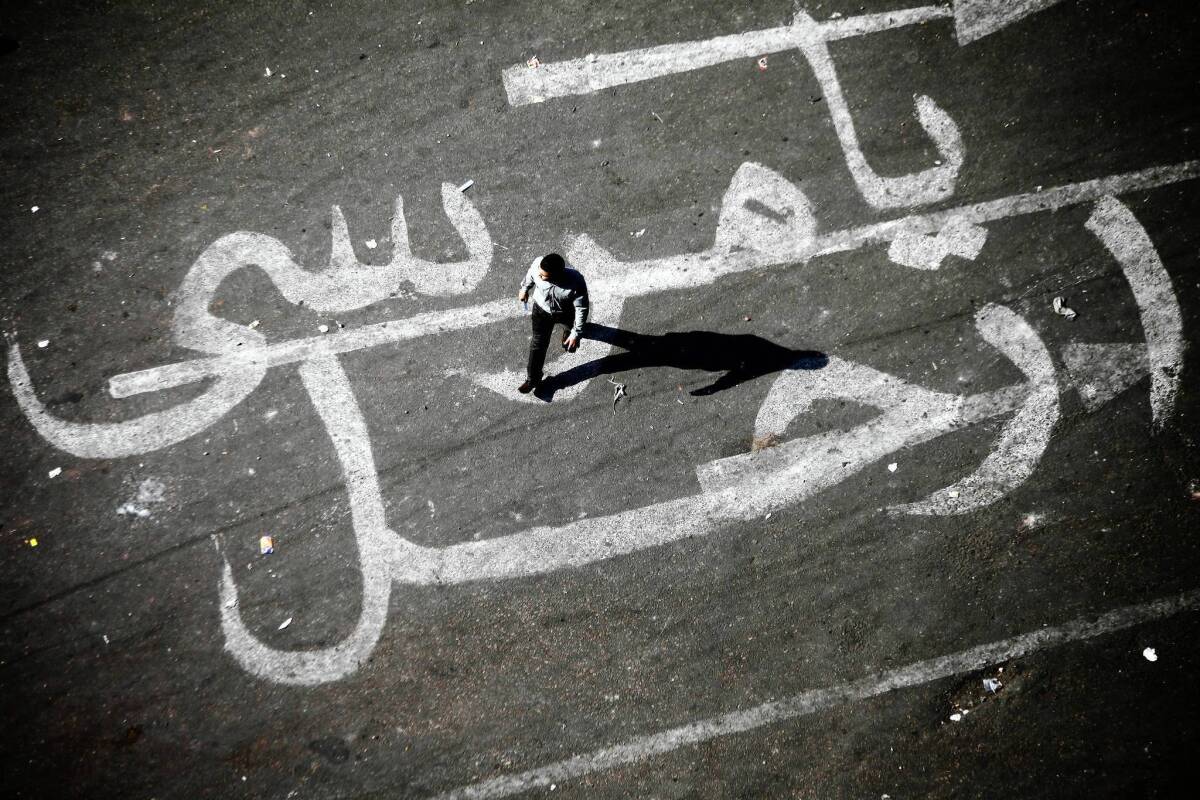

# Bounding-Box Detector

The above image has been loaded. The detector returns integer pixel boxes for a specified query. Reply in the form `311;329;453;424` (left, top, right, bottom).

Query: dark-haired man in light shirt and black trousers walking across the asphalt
517;253;589;395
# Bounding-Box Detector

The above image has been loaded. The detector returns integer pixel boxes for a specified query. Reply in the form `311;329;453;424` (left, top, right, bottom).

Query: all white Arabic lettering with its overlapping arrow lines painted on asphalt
8;2;1200;685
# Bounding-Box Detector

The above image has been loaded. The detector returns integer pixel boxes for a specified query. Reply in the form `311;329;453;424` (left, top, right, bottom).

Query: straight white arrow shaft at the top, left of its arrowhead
502;6;954;106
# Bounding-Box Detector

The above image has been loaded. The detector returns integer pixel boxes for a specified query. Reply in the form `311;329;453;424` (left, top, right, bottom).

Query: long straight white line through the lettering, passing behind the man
100;161;1200;398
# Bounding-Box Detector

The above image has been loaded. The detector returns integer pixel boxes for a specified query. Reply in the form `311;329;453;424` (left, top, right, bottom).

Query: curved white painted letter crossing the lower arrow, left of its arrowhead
890;306;1058;515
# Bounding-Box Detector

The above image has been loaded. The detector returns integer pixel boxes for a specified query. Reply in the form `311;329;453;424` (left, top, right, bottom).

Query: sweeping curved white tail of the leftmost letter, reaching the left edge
8;344;266;458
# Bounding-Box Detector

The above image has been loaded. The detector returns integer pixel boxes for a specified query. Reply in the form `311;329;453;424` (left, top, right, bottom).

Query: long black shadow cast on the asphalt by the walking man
535;324;829;399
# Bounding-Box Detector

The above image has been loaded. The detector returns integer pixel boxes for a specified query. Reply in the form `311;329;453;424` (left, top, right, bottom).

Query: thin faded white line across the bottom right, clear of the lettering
432;590;1200;800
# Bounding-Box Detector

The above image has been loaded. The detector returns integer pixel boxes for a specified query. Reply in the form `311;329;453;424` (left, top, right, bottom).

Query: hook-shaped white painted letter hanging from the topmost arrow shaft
792;8;962;209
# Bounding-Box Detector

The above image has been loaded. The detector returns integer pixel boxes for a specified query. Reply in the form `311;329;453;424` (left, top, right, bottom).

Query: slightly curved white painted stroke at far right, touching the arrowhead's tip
1086;197;1186;431
